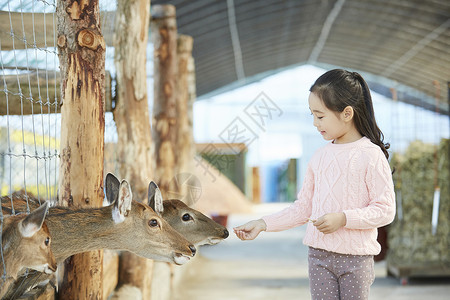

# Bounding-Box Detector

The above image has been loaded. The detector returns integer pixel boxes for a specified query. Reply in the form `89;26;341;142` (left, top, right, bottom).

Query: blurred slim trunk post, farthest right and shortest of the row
173;35;195;205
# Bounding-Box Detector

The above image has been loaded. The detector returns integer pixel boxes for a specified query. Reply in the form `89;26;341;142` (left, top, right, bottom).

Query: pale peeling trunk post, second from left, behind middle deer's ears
114;0;154;299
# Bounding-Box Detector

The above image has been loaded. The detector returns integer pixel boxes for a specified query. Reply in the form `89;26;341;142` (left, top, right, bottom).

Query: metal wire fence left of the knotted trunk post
0;0;60;290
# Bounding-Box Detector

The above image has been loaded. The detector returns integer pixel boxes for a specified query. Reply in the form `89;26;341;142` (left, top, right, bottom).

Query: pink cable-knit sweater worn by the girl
263;137;395;255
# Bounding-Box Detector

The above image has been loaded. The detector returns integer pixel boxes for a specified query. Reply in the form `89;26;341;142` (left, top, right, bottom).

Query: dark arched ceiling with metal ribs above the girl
151;0;450;113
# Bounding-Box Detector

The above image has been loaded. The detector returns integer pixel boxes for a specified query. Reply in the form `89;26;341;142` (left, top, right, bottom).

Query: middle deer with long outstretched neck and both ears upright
2;173;196;298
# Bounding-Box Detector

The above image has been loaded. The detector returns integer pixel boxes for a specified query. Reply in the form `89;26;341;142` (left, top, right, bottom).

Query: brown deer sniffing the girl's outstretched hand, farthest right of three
148;181;229;246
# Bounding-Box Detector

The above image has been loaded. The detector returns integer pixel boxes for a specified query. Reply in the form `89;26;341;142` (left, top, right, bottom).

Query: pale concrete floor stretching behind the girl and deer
172;204;450;300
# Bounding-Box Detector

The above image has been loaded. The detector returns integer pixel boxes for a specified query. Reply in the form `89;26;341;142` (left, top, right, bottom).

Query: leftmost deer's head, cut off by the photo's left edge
0;203;56;298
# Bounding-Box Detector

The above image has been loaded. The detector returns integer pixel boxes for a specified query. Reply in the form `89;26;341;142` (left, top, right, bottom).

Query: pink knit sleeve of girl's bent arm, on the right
344;151;395;229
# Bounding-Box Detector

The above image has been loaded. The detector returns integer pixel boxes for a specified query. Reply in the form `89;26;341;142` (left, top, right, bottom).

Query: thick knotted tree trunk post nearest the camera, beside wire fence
57;0;106;299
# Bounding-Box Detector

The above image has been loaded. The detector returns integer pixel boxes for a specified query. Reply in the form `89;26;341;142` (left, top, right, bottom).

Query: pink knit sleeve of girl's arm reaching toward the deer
262;165;314;231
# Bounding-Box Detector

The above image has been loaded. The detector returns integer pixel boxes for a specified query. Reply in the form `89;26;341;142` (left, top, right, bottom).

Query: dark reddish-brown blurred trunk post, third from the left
151;5;178;300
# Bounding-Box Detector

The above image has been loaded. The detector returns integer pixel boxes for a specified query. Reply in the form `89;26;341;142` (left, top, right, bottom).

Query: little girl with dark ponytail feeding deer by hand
234;69;395;300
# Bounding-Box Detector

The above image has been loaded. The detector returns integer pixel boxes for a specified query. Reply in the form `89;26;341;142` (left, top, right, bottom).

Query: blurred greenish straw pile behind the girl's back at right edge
388;139;450;272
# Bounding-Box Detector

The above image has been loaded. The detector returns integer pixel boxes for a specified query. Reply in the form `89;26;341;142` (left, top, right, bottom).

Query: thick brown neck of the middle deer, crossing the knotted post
46;206;117;261
